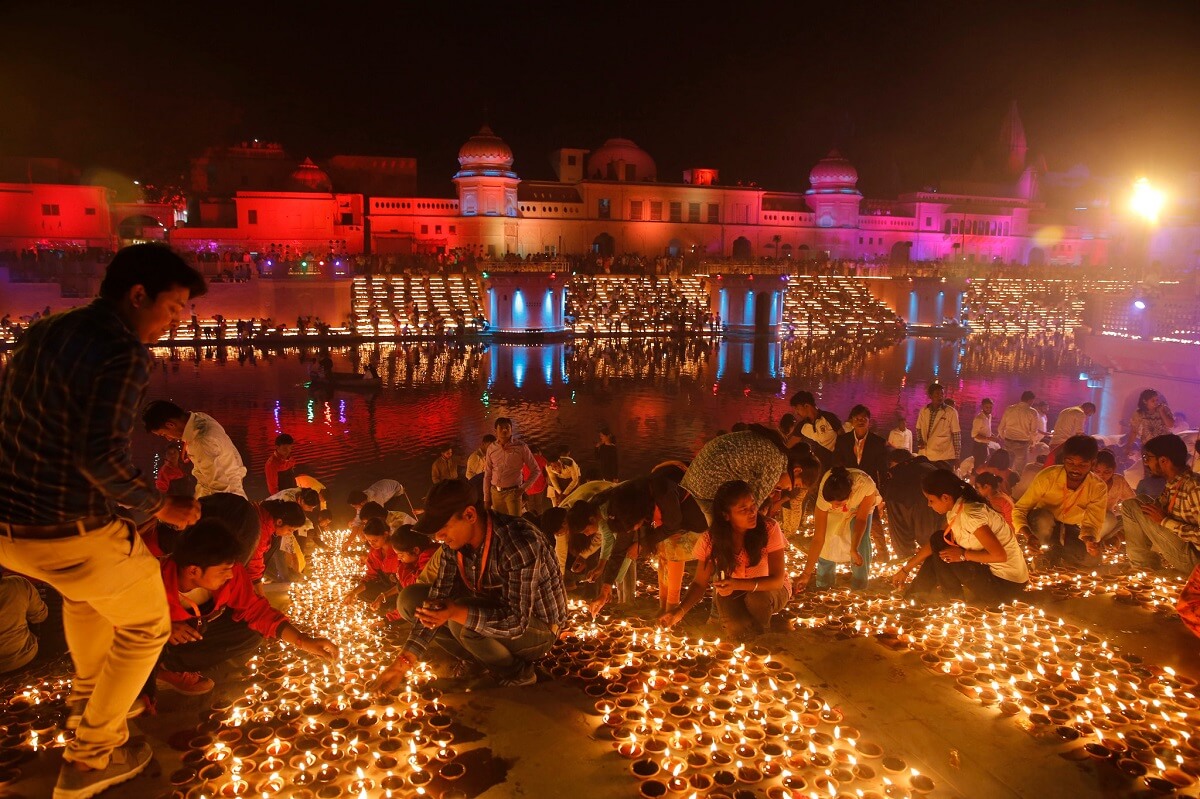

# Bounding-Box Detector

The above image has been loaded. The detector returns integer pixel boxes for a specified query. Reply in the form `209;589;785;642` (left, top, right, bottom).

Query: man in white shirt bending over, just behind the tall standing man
142;400;246;499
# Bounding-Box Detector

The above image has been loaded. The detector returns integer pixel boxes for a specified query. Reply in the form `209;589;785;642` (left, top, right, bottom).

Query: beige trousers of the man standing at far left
0;521;170;769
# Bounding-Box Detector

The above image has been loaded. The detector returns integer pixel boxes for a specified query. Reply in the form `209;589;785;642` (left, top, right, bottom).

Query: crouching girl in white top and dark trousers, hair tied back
894;469;1030;605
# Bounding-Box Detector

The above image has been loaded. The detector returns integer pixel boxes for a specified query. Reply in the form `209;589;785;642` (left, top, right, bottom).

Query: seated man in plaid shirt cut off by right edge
1121;433;1200;572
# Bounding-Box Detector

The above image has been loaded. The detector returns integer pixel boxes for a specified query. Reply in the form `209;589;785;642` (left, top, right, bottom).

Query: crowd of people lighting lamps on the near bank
0;245;1200;799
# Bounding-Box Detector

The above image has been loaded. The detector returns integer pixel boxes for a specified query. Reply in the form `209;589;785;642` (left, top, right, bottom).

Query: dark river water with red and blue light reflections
110;328;1100;505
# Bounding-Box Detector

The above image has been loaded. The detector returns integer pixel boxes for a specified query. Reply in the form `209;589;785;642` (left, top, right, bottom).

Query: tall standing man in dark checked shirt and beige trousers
0;245;205;799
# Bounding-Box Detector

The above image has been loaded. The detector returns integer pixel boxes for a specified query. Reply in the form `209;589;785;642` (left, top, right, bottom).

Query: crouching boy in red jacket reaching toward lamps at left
156;521;337;696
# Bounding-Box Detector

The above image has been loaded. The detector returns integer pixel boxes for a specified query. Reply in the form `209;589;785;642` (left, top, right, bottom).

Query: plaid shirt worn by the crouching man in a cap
404;511;566;660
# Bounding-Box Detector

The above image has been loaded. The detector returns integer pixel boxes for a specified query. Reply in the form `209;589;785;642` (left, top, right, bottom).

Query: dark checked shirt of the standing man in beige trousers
0;300;164;524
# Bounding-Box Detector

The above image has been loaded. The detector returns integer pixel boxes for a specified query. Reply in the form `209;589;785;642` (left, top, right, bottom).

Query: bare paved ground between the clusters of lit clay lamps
0;554;1200;799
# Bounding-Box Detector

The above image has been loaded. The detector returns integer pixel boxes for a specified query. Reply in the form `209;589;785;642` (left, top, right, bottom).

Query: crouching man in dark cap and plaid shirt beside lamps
378;480;566;691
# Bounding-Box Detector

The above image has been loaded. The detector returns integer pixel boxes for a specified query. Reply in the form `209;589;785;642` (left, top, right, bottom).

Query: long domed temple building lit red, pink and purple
0;103;1200;266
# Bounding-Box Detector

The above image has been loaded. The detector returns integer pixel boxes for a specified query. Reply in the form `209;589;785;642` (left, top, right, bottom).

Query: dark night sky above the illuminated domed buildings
0;0;1200;197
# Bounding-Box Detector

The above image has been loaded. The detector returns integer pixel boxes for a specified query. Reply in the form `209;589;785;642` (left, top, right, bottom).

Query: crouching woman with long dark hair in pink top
659;480;792;638
